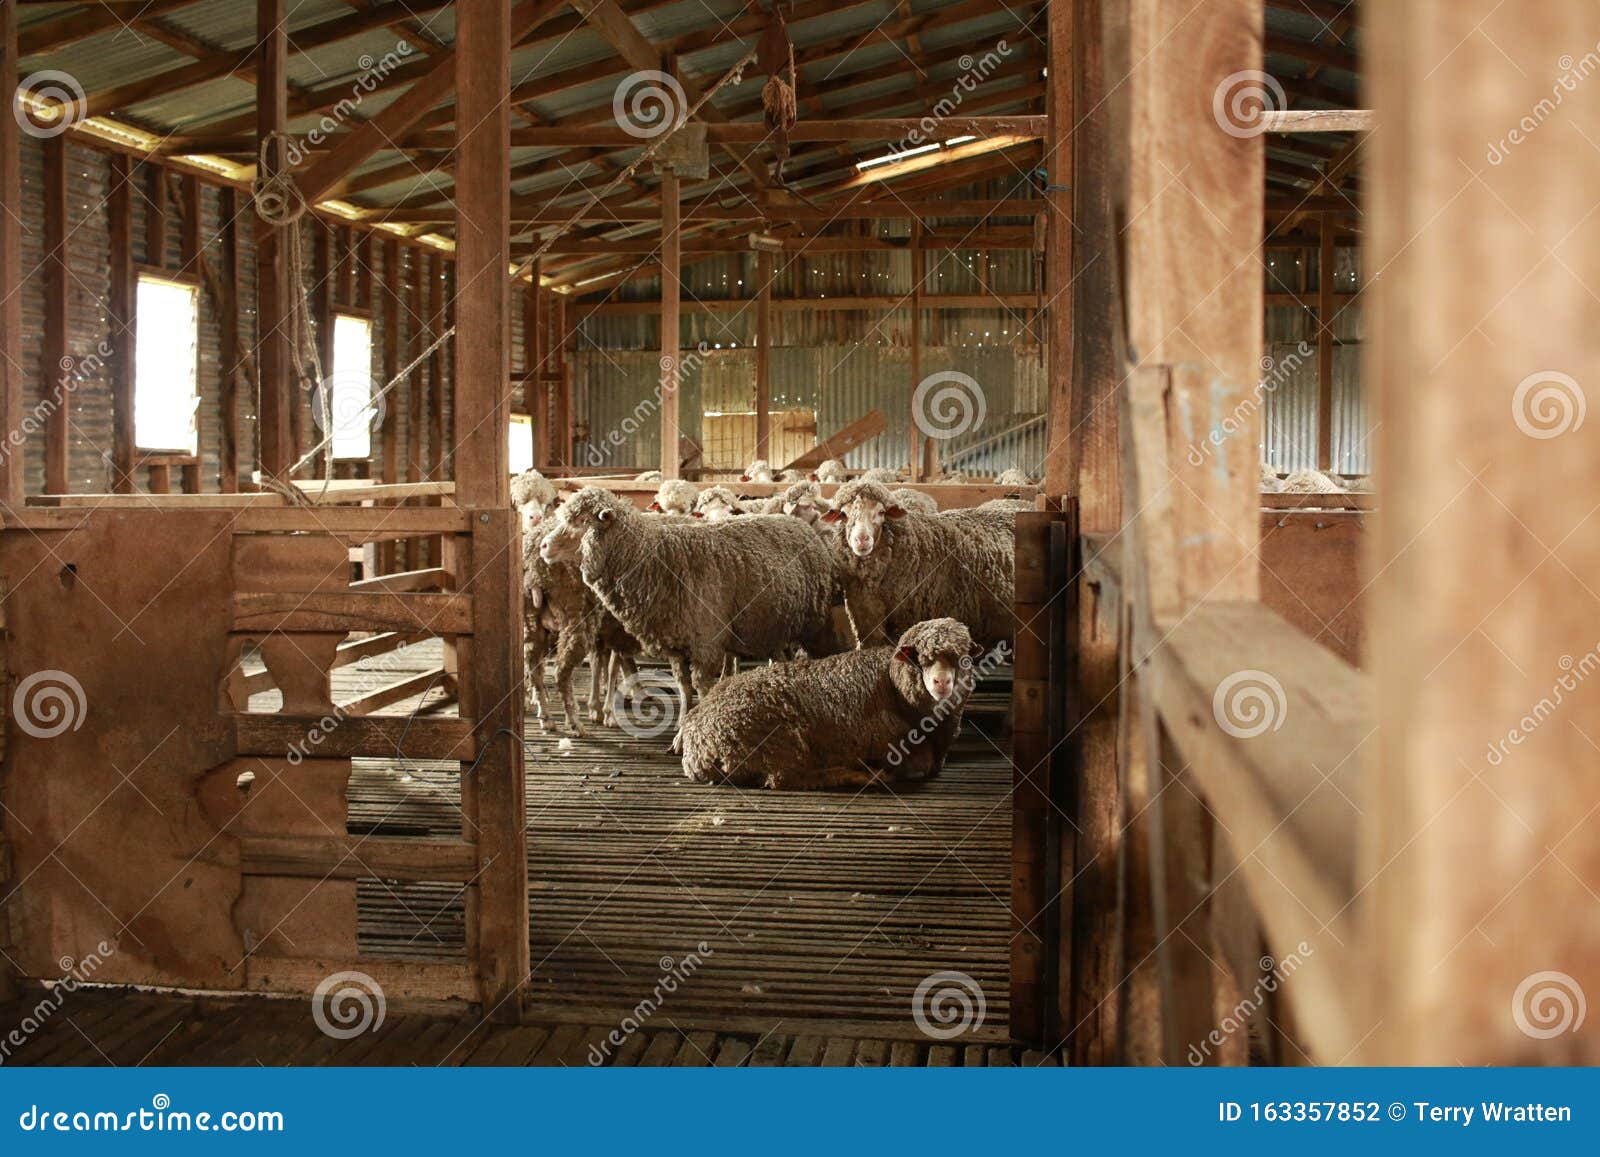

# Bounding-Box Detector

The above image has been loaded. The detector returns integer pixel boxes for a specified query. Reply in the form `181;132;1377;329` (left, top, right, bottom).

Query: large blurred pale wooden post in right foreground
1352;0;1600;1066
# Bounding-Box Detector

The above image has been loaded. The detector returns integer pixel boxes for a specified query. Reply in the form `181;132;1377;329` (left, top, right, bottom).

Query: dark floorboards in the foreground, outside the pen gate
0;991;1056;1067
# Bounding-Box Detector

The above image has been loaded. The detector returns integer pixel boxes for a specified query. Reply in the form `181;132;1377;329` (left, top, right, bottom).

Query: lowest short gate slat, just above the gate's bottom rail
238;835;477;883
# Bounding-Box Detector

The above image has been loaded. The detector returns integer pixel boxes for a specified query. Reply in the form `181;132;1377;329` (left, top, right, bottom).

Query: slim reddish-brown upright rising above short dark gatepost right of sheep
1045;0;1078;498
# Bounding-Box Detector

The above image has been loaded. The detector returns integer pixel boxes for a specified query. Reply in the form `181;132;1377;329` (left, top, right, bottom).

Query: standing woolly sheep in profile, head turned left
541;486;837;719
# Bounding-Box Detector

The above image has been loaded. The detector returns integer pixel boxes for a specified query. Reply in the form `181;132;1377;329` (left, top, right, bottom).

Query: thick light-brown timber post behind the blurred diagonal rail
1114;0;1266;1064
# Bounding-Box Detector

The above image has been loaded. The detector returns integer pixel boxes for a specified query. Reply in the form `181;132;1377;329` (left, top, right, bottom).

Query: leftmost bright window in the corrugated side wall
133;274;200;454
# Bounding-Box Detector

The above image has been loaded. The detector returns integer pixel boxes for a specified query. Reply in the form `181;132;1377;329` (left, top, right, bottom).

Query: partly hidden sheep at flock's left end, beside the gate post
522;528;640;738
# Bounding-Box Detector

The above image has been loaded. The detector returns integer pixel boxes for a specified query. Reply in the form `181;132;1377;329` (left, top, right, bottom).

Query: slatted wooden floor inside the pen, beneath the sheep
241;642;1011;1043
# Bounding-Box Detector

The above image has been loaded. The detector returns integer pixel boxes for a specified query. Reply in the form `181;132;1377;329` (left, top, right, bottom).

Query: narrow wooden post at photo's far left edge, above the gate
0;5;26;507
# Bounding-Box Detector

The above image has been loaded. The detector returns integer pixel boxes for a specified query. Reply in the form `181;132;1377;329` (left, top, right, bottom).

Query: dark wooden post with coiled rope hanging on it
256;0;299;475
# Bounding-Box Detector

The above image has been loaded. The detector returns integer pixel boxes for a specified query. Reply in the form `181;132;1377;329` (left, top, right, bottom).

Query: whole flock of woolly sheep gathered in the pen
512;461;1030;789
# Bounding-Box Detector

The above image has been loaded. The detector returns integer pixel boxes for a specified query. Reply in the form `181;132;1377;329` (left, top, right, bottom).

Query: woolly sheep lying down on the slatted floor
675;619;982;791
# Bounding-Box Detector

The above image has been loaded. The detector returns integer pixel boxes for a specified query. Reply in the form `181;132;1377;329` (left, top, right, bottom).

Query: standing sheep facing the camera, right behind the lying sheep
822;478;1016;643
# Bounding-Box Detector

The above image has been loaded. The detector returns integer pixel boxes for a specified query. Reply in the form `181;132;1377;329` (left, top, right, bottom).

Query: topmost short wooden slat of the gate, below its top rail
234;591;474;635
